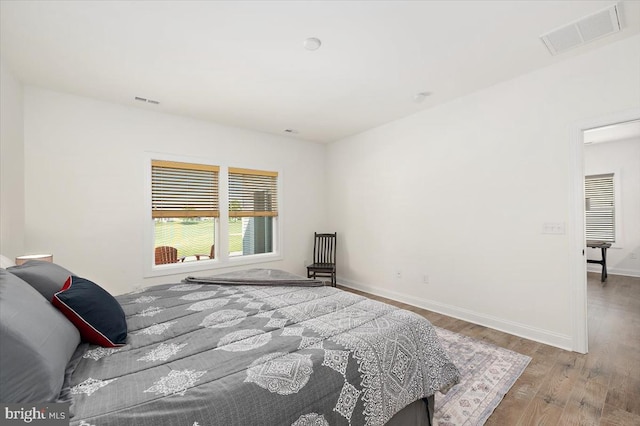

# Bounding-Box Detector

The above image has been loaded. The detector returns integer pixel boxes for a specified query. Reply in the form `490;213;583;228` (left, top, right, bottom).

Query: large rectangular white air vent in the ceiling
540;4;620;55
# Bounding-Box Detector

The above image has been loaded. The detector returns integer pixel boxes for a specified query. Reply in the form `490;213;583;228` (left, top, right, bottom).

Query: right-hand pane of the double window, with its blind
228;168;278;256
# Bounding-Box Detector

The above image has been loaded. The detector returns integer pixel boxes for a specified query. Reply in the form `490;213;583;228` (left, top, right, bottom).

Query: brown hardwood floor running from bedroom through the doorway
345;273;640;426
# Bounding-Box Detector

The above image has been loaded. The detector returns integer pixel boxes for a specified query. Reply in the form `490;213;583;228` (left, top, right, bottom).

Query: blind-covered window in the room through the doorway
584;173;616;243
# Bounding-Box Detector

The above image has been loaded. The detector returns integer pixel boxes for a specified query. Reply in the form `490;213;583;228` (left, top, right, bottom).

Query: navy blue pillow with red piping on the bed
51;275;127;348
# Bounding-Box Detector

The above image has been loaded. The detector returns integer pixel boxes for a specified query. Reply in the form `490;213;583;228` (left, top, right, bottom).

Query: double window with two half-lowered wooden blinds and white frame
149;154;281;276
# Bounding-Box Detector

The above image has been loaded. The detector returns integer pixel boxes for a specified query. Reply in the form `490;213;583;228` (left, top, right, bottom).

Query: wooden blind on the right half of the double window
229;167;278;217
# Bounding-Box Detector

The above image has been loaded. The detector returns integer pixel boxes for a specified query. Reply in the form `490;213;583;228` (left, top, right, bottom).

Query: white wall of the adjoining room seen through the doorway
584;138;640;277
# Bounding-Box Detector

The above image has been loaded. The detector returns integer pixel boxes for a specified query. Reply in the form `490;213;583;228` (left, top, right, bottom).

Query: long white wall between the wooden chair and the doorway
327;36;640;348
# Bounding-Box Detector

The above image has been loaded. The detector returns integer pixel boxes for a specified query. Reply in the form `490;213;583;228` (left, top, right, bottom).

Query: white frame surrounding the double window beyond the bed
143;152;284;278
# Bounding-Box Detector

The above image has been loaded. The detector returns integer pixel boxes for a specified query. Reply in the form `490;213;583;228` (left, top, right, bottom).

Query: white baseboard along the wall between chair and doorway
337;277;573;351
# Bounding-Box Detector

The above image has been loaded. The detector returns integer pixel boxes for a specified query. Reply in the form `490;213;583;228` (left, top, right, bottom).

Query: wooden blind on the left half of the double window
151;160;220;218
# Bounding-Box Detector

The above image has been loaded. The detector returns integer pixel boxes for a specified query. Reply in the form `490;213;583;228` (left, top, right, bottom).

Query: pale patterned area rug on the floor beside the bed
434;327;531;426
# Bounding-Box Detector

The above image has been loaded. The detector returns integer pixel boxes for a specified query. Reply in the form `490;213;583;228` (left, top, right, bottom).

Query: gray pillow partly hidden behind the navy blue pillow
7;260;75;301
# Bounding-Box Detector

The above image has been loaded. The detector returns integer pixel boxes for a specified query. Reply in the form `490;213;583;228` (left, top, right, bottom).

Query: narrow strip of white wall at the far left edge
0;58;25;259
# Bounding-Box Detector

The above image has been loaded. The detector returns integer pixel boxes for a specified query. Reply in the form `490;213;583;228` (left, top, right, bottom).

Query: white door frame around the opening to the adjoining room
569;108;640;354
